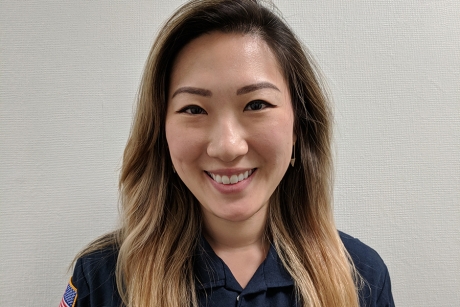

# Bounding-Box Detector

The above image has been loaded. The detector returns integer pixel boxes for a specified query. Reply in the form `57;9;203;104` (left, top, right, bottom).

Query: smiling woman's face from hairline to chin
166;32;295;222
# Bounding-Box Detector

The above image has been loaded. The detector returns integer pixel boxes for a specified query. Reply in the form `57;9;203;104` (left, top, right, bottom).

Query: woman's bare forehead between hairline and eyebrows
170;32;284;92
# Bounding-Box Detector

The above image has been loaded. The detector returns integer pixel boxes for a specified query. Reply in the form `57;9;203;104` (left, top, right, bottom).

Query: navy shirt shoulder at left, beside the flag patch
71;247;121;306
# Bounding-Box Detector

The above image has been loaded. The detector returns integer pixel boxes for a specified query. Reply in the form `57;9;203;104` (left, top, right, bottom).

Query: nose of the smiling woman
207;118;248;162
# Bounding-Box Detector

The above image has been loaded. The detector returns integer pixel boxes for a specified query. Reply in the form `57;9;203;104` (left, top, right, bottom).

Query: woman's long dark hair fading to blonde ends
80;0;359;307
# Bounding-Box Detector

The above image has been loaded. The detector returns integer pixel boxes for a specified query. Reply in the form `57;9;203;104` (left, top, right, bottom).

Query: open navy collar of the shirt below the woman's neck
194;236;294;293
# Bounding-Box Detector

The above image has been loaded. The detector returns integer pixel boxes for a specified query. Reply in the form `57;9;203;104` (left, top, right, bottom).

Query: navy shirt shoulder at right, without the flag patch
339;231;394;307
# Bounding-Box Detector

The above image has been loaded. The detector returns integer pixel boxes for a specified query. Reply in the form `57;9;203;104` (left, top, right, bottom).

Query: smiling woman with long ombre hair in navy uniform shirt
59;0;394;307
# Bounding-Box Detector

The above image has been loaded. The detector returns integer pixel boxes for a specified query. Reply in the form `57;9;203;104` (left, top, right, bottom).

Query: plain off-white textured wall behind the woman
0;0;460;307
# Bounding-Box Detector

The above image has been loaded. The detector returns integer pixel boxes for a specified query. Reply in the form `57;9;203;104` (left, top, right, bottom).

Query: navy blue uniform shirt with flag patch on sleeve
63;232;394;307
